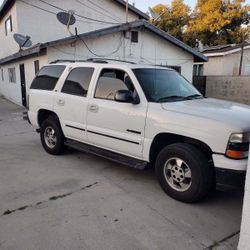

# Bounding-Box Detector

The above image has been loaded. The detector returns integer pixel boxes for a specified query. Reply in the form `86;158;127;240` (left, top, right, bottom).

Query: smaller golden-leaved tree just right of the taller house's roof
153;0;190;40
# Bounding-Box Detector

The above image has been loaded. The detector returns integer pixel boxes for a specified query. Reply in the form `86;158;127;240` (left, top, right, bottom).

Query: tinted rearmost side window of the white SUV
30;65;66;90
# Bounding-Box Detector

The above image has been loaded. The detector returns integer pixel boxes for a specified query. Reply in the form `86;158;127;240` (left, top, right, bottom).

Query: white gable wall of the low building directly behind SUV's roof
48;31;193;82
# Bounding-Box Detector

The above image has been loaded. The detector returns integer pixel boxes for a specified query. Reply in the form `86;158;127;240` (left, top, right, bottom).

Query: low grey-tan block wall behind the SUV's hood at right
206;76;250;105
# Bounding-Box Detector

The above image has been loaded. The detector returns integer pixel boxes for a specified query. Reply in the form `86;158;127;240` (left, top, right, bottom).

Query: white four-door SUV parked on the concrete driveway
28;60;250;202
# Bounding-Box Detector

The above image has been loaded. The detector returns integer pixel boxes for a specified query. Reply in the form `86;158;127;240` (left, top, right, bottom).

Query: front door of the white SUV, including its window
87;68;147;158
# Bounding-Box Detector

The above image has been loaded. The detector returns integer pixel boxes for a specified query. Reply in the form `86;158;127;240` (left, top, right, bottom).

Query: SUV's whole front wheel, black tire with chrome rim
155;143;215;203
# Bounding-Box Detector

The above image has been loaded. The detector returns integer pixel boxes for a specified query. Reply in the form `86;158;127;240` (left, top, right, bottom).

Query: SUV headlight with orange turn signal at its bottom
226;133;250;160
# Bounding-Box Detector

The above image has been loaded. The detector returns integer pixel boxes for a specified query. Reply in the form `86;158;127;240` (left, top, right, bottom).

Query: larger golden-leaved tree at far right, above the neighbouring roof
185;0;250;45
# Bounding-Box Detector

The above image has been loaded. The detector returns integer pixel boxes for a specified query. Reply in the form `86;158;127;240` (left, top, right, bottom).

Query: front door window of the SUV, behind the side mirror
95;69;134;100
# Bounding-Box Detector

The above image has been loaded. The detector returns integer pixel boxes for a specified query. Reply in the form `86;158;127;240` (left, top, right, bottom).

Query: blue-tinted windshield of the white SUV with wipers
133;68;203;102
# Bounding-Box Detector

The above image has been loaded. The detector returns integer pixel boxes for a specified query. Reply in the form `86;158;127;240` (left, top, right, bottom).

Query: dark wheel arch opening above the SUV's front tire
149;133;213;164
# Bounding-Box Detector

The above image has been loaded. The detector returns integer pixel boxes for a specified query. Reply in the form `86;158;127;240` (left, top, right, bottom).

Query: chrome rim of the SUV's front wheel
164;157;192;192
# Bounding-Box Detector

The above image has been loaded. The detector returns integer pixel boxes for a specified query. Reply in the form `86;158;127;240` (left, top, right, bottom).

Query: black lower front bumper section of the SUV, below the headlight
215;168;246;187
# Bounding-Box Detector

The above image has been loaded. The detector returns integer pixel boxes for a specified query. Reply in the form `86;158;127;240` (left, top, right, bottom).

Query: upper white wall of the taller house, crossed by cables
17;0;138;47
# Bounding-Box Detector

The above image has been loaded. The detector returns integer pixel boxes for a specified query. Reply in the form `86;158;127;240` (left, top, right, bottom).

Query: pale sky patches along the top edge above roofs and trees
0;0;250;12
